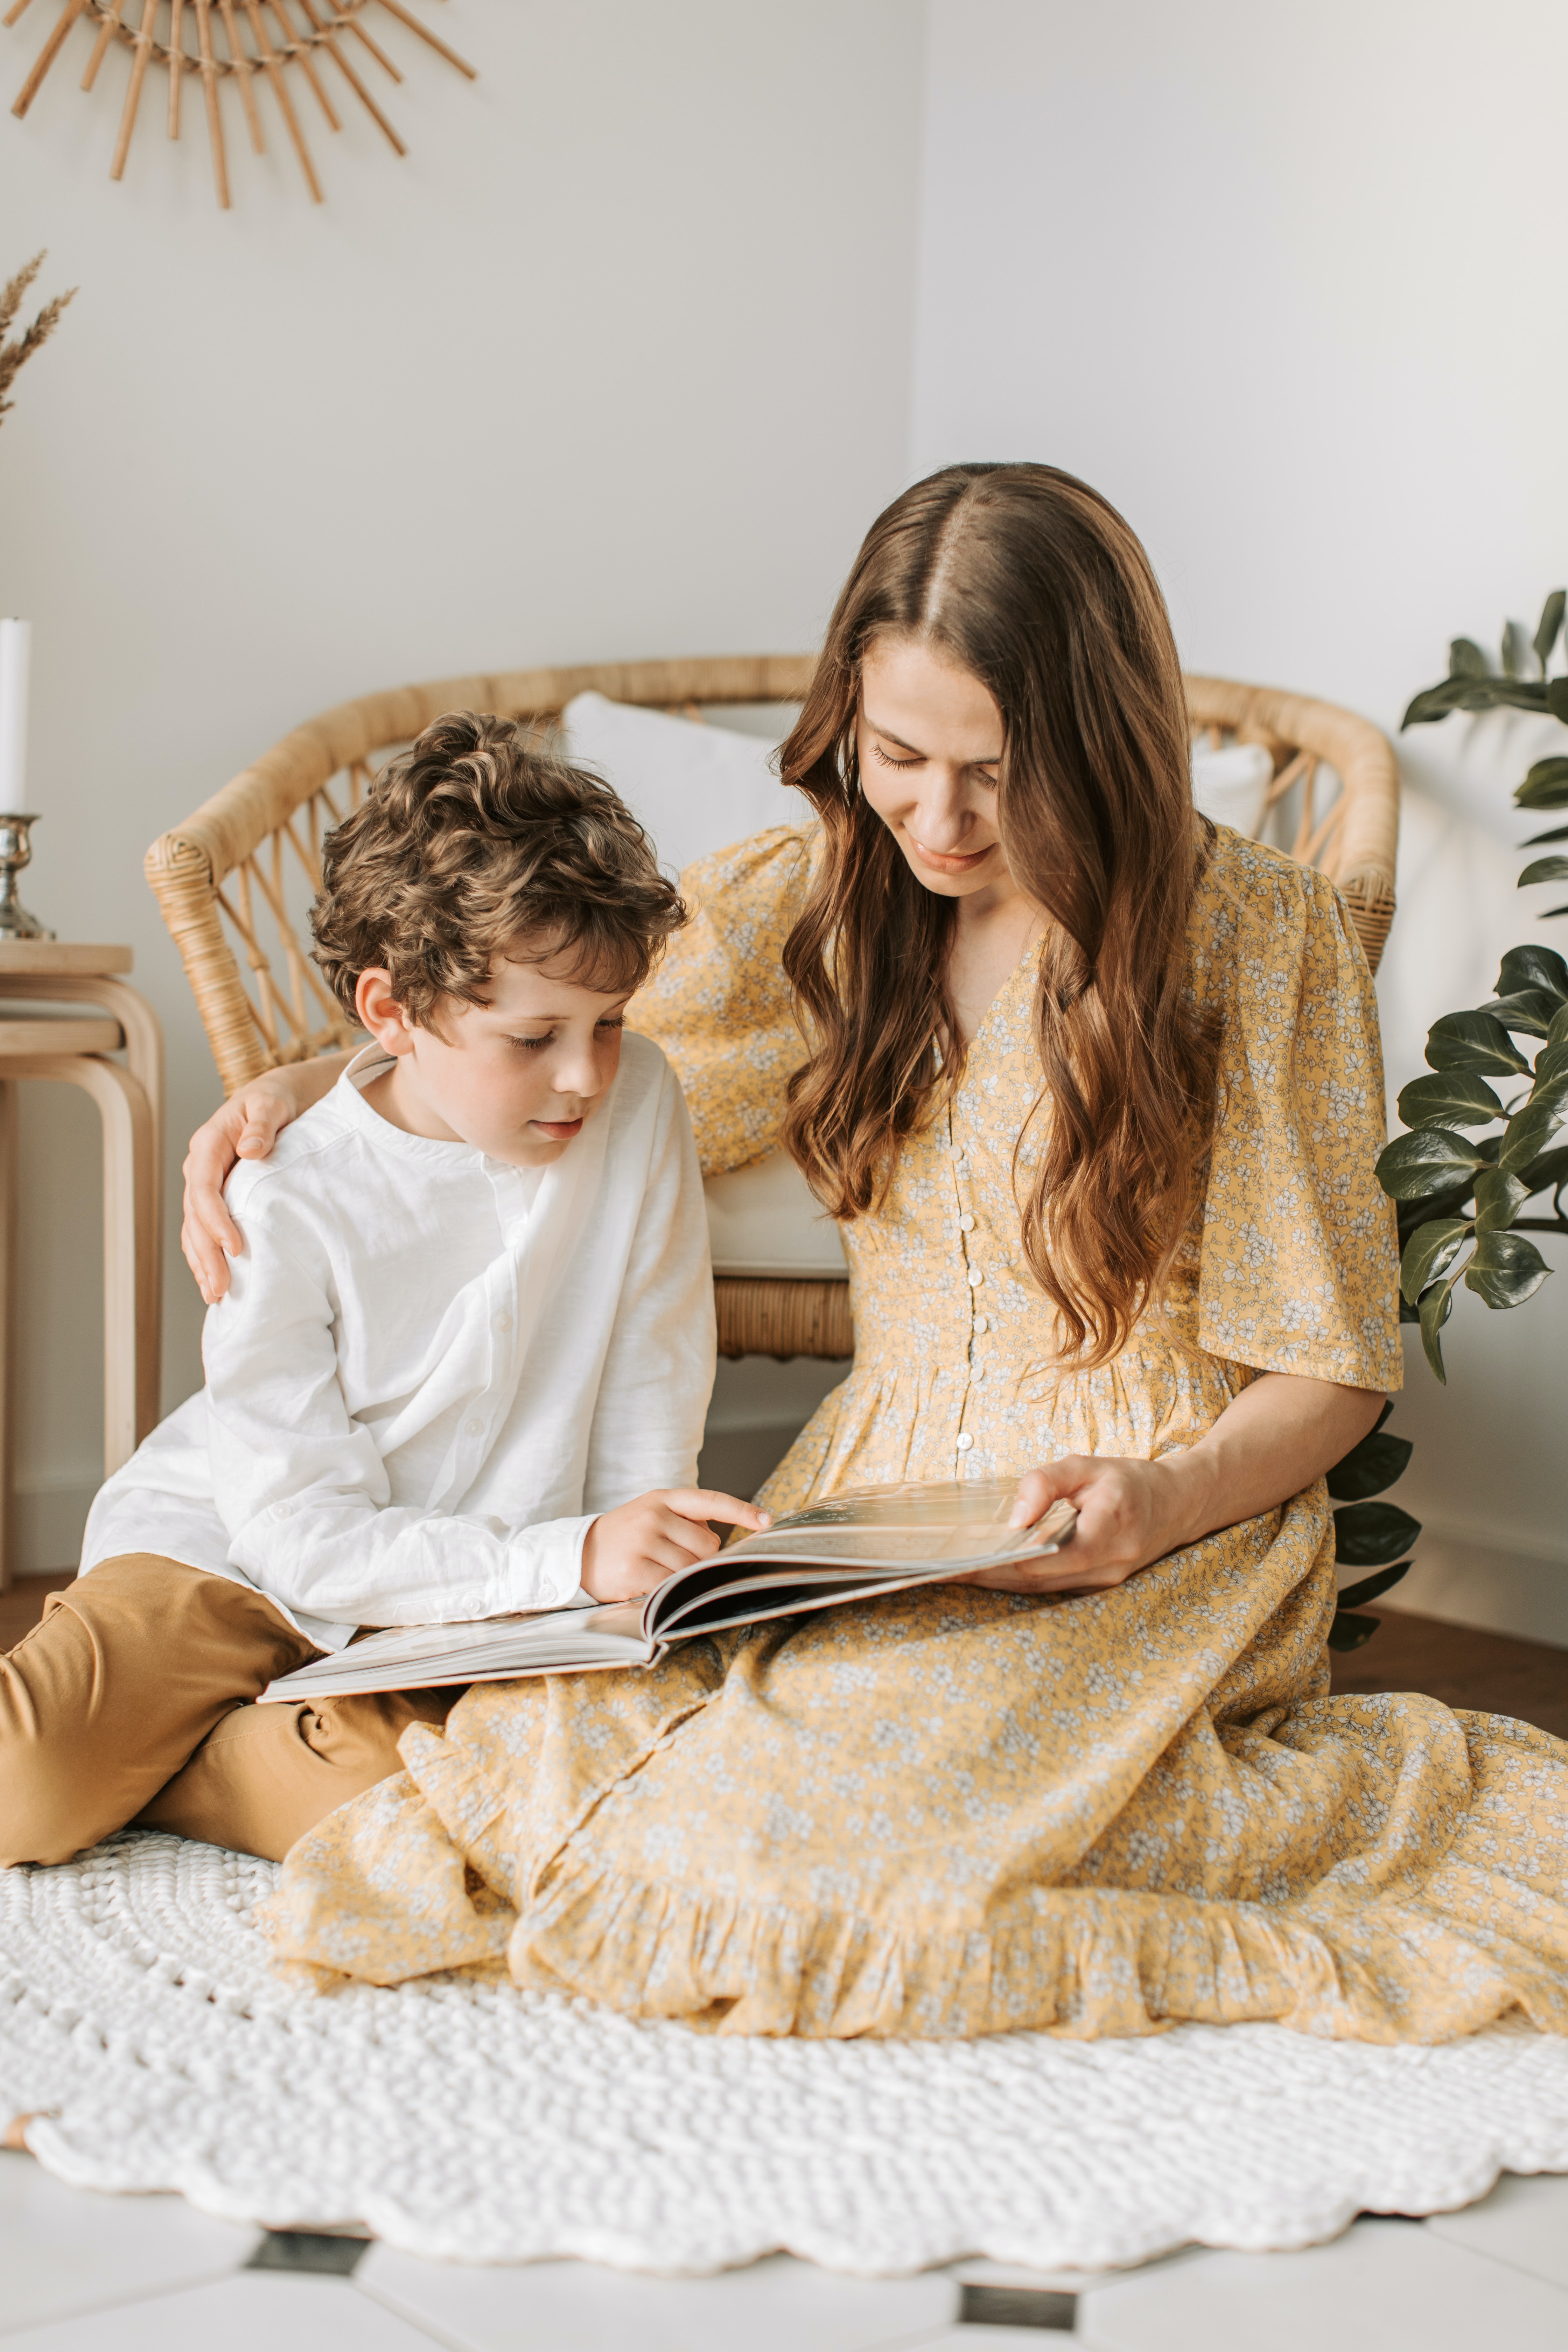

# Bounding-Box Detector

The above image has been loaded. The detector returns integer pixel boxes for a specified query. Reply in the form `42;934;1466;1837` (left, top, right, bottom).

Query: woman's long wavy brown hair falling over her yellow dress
780;466;1216;1369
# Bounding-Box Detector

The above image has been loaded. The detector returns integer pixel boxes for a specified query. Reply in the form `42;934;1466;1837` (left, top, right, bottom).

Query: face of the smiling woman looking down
856;637;1013;898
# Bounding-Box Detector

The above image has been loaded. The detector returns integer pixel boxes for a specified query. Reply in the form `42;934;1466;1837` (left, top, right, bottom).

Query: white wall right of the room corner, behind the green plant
910;0;1568;1642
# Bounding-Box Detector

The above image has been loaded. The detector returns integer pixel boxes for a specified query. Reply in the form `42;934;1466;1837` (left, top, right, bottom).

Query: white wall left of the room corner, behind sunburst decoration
0;0;924;1569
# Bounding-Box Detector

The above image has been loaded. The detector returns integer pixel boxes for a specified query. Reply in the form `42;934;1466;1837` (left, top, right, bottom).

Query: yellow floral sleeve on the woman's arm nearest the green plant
1192;833;1404;1390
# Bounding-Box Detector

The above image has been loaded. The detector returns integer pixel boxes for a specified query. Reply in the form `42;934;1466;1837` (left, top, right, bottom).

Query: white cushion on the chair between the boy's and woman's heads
562;694;811;875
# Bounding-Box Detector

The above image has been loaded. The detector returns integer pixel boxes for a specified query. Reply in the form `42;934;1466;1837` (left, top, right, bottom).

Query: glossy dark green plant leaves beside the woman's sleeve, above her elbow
1378;588;1568;1383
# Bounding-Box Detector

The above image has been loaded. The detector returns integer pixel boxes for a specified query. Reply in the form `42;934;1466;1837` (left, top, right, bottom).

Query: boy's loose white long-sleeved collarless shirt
82;1032;715;1649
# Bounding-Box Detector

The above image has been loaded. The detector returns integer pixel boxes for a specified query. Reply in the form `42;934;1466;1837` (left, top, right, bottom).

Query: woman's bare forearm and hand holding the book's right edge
964;1371;1385;1592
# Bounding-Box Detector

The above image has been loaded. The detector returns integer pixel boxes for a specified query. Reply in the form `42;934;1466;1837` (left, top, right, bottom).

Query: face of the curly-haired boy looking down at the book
355;936;630;1169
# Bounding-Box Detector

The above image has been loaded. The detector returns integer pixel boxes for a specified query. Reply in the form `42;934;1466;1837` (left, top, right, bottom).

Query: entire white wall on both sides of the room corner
0;0;1568;1642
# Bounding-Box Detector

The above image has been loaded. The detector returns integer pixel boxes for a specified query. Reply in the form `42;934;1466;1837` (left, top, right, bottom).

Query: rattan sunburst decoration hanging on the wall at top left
0;0;477;212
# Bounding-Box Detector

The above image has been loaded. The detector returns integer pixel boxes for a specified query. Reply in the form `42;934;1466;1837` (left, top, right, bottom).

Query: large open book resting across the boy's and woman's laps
261;1479;1077;1701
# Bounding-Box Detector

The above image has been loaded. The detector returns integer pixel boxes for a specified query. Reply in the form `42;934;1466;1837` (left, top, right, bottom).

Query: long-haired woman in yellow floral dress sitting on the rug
190;466;1568;2039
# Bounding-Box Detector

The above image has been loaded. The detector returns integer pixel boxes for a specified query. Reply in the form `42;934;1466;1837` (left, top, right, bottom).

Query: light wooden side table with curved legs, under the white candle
0;938;164;1592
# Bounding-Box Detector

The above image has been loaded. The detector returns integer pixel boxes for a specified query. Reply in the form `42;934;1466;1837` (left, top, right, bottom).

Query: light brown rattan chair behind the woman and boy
146;654;1399;1357
